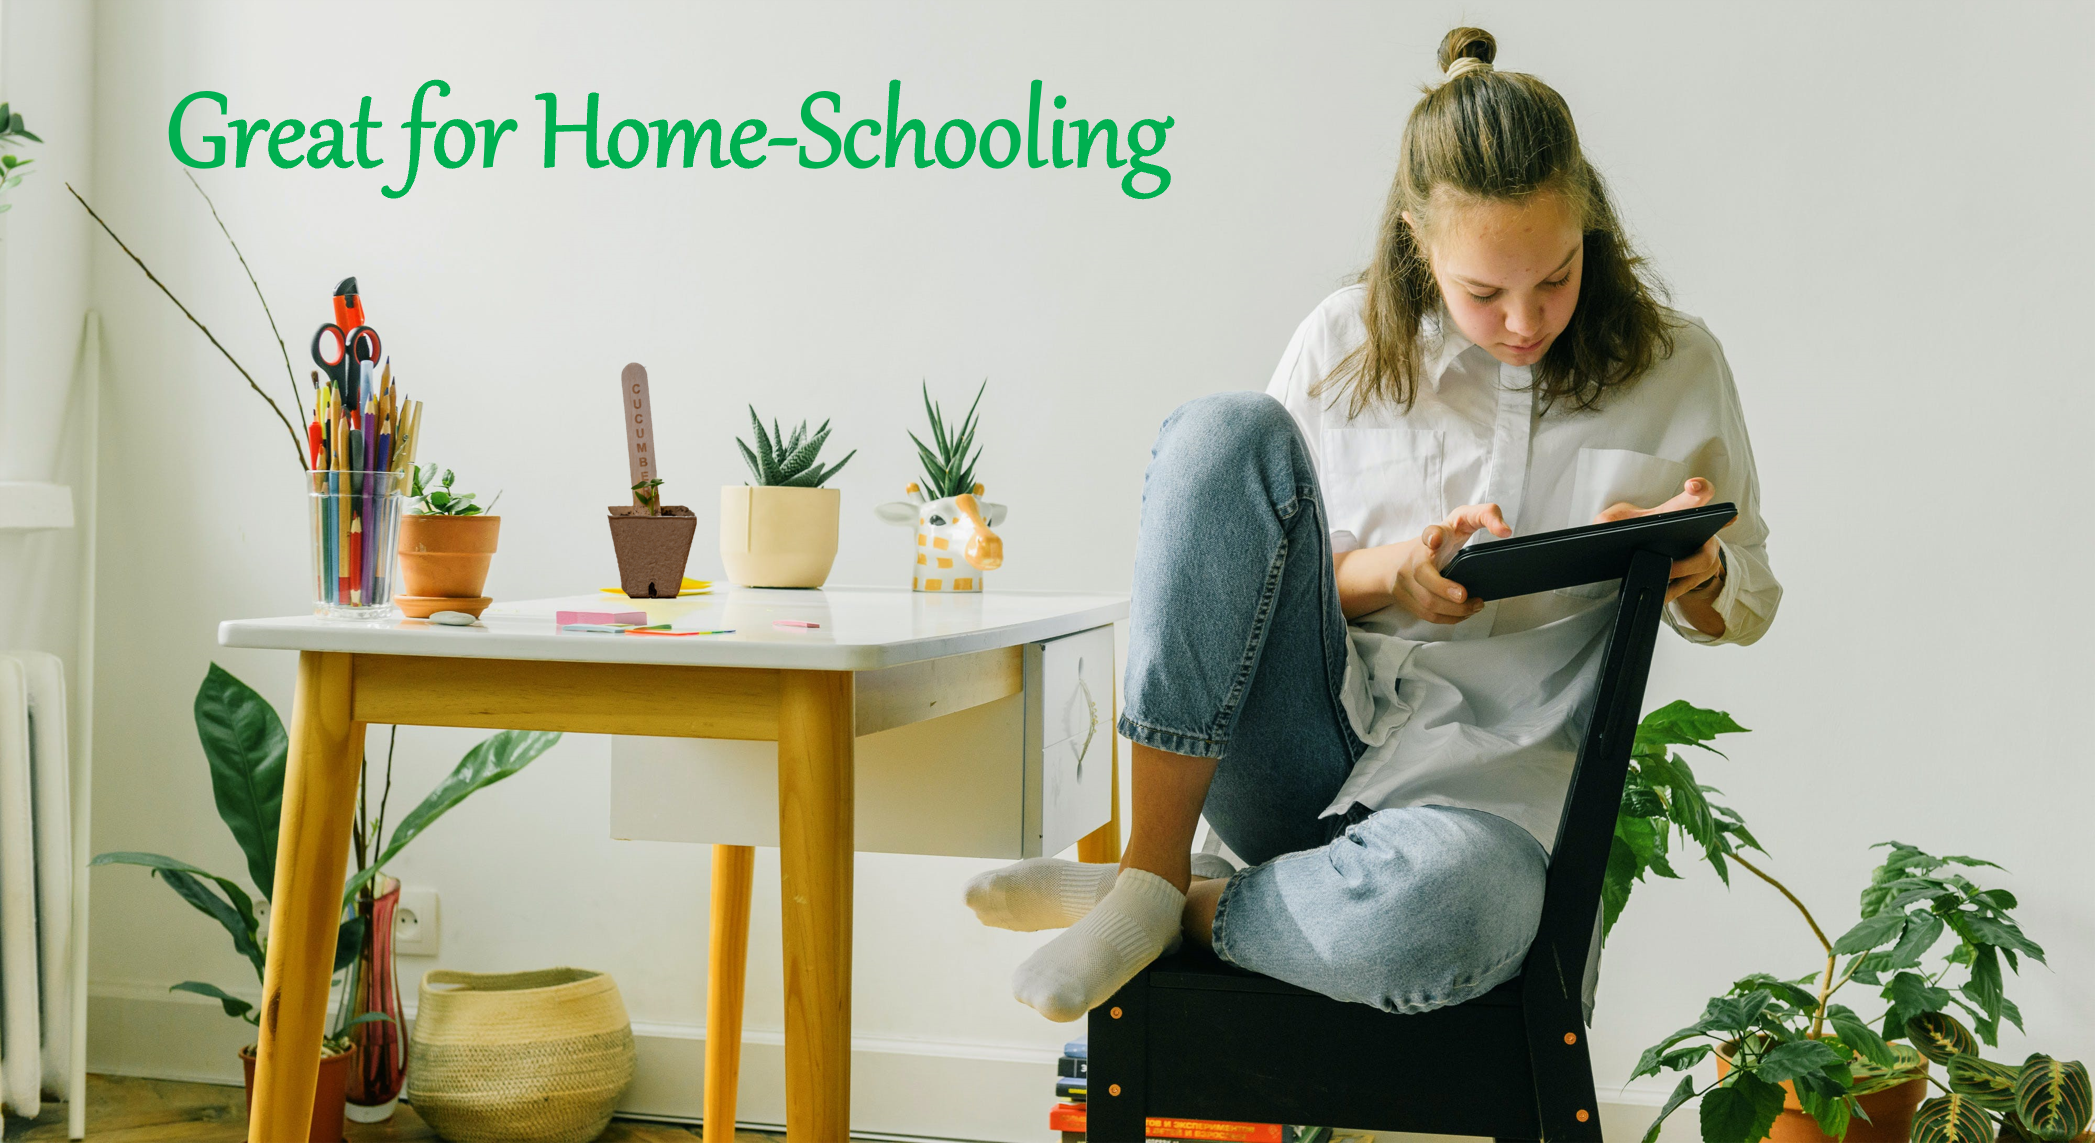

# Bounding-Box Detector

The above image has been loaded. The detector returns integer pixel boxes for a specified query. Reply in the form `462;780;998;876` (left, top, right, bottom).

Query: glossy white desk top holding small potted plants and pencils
218;584;1127;670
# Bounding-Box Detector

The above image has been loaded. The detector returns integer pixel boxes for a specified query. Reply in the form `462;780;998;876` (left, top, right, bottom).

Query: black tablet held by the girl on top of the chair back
1441;505;1739;599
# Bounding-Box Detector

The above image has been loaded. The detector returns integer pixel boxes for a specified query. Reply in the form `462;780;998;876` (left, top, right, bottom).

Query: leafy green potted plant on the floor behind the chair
1603;703;2080;1143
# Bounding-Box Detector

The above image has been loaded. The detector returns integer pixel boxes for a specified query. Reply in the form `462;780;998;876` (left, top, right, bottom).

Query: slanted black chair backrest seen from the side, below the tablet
1521;553;1672;1007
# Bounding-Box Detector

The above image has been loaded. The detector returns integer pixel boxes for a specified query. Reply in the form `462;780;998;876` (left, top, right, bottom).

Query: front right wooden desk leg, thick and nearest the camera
779;670;853;1143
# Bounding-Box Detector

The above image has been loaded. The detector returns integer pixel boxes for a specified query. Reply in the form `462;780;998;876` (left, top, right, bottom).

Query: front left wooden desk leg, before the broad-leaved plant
247;651;365;1143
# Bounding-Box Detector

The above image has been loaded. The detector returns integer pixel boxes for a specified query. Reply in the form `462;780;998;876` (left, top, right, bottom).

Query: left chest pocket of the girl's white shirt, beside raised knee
1318;427;1448;548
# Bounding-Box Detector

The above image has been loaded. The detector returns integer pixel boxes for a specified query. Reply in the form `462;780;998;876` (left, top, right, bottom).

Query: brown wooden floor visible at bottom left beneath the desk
4;1076;821;1143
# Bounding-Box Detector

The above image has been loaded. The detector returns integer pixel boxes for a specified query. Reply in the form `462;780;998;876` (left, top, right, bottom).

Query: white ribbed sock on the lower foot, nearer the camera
1012;869;1186;1022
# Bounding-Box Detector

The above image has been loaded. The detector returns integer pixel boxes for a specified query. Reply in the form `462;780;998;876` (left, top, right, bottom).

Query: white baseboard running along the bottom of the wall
88;984;1697;1143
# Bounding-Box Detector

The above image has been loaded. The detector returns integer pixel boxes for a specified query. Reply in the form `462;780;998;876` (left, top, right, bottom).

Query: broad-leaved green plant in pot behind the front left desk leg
92;664;559;1143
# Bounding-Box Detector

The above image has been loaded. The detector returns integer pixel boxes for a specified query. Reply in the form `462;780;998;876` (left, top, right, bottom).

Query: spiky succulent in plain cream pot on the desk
721;406;859;588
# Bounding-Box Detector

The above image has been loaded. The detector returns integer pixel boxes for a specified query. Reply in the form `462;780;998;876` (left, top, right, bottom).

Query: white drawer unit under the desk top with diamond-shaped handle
612;626;1117;858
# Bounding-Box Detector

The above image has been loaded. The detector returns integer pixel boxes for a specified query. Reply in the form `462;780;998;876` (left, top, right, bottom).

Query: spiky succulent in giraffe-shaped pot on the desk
874;381;1008;592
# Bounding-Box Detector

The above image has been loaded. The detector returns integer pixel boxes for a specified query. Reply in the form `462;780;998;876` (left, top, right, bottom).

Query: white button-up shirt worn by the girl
1267;287;1783;848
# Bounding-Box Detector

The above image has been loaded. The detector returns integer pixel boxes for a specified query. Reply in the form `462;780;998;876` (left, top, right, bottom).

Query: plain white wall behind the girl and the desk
69;2;2095;1139
